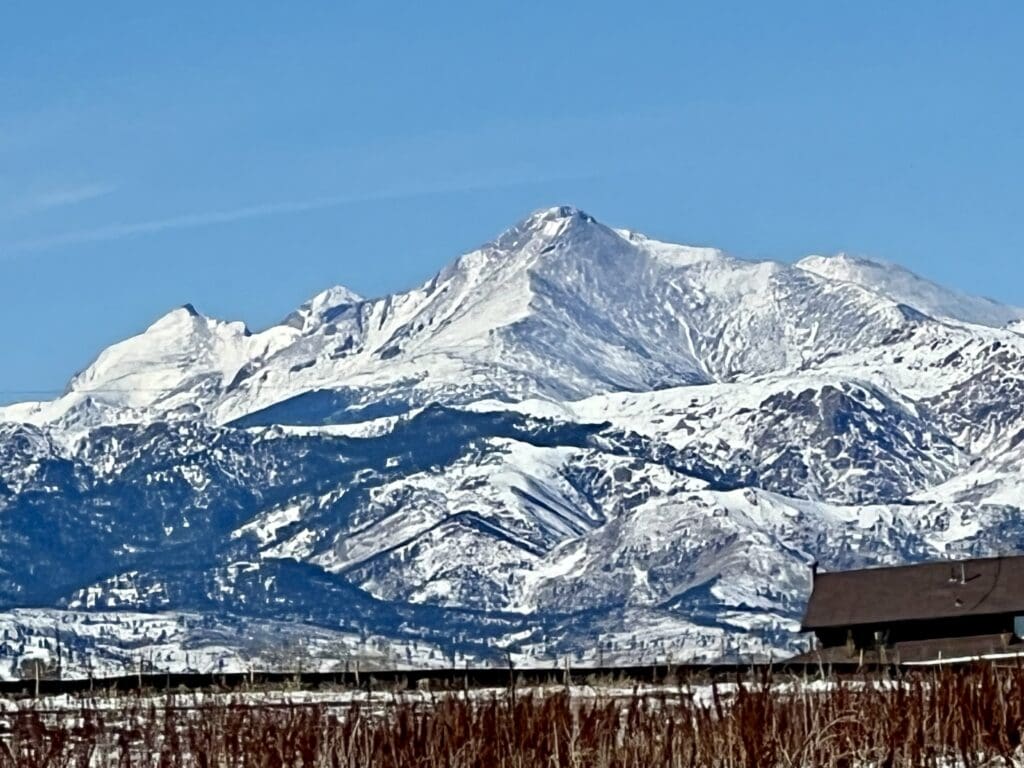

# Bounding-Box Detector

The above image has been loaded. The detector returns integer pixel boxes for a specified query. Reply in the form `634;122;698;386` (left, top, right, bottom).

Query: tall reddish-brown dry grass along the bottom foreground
0;667;1024;768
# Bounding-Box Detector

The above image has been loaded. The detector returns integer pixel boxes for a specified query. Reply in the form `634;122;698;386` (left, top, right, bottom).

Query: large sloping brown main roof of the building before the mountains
803;556;1024;630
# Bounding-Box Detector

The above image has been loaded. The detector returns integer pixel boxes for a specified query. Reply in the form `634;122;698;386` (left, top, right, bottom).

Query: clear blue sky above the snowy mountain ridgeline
0;0;1024;400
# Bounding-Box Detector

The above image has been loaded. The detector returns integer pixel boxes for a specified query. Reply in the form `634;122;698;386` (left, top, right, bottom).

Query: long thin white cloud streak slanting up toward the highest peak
0;177;598;254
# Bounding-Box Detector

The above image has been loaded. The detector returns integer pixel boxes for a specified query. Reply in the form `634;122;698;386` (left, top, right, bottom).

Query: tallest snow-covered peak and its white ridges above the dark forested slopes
0;208;914;434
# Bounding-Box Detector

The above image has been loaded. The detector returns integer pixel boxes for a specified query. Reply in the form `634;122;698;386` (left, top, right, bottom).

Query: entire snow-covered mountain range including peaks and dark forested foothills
0;207;1024;674
